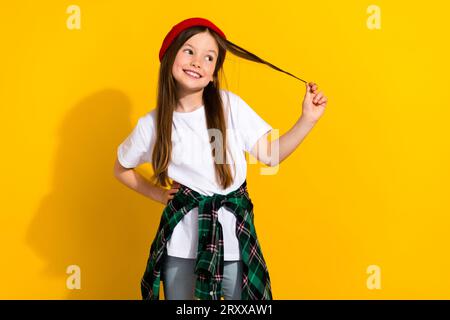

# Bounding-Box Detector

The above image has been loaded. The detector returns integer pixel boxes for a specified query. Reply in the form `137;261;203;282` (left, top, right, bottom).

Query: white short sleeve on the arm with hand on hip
117;113;155;169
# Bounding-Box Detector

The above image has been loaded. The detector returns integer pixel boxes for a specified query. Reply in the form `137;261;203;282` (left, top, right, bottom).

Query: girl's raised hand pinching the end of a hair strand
301;82;328;123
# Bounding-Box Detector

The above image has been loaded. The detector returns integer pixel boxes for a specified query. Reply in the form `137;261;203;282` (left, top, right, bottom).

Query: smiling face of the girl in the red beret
172;31;219;91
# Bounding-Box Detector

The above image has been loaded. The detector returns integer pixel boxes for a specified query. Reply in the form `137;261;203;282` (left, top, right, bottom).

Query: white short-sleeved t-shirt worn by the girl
117;90;272;261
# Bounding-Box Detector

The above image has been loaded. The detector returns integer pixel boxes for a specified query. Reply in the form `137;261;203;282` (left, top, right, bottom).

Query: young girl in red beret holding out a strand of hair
115;18;327;300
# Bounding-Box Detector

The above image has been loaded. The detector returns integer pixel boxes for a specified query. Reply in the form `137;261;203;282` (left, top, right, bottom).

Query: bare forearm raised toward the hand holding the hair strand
271;117;316;166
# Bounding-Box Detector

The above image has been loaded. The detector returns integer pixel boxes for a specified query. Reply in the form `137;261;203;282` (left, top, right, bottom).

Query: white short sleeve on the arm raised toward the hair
231;94;273;152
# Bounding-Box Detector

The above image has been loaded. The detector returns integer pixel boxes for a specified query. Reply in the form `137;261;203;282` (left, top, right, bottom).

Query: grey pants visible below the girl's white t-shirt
161;255;242;300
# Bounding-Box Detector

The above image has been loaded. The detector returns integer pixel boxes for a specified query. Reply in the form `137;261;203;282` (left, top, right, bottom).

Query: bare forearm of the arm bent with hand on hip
115;169;164;202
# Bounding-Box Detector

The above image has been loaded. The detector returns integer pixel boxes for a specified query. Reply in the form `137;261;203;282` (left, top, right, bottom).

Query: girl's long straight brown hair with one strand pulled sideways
151;26;306;189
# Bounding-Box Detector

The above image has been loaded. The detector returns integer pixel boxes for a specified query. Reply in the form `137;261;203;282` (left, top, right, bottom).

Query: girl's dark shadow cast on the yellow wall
27;89;164;299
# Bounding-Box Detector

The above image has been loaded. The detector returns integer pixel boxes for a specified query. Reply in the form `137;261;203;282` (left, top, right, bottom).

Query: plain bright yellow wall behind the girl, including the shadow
0;0;450;299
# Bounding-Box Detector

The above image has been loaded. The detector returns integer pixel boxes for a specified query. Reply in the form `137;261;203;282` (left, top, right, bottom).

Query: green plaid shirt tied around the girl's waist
141;181;272;300
